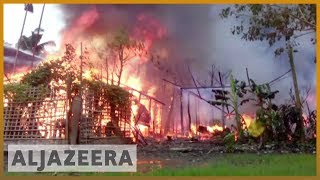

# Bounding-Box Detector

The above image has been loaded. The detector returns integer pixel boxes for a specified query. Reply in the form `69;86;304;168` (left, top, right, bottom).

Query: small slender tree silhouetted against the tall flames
109;27;144;86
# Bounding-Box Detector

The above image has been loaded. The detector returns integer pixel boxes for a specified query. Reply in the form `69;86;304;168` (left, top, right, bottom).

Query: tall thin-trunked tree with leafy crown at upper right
221;4;316;140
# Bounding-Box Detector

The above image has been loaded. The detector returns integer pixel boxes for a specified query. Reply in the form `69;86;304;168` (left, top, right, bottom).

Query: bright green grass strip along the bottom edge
7;154;316;176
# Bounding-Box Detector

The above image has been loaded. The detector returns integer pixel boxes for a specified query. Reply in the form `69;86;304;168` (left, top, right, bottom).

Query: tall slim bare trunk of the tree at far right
288;45;304;141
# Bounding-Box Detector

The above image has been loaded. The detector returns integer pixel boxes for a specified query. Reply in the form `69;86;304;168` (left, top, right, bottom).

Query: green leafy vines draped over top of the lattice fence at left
5;44;131;108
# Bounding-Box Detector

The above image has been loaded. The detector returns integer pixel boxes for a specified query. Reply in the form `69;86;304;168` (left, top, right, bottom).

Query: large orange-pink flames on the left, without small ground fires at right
4;7;167;139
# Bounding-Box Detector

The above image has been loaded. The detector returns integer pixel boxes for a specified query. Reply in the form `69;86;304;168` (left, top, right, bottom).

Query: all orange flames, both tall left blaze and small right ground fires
5;6;260;142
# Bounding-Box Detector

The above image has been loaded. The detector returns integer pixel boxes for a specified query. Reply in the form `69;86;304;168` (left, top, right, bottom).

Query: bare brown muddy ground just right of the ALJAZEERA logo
137;139;231;172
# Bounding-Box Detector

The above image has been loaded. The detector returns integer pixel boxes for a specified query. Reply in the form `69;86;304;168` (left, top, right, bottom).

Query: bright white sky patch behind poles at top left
4;4;64;48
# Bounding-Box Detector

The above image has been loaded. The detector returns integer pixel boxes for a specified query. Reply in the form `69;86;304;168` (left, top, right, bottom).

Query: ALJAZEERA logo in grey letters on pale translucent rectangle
8;145;137;172
